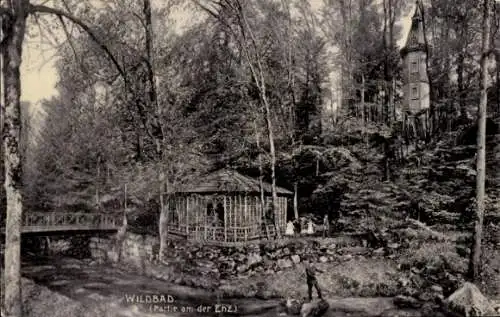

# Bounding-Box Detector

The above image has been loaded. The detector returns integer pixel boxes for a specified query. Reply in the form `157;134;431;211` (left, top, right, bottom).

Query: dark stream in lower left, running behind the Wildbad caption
22;256;279;317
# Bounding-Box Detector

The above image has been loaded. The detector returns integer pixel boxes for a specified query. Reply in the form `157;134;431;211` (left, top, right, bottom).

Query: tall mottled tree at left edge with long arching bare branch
0;0;146;317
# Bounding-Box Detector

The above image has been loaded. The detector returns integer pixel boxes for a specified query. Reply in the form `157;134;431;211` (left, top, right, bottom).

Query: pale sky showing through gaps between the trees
17;0;410;107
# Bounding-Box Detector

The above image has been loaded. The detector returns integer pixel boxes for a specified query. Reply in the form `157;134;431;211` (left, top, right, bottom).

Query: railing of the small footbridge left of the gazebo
23;212;120;229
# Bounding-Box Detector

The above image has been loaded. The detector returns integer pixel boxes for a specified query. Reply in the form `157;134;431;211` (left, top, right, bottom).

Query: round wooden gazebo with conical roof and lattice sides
167;170;293;245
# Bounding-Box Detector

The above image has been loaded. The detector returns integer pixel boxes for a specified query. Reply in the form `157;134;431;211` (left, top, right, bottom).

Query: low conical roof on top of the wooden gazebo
178;169;293;195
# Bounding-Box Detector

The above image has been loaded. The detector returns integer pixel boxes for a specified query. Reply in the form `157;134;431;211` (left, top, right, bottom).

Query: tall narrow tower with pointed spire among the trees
401;0;430;114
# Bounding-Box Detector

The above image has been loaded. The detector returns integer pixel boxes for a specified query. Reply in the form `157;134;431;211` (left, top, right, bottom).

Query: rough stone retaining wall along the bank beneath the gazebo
90;233;368;289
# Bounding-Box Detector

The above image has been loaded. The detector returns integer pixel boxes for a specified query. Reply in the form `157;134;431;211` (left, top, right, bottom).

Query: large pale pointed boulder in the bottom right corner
444;282;496;316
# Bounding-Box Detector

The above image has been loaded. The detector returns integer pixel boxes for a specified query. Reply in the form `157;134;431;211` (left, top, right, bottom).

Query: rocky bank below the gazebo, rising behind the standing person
90;228;476;299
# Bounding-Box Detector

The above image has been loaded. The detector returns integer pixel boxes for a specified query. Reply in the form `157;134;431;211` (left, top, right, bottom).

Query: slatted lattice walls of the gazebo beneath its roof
167;193;287;244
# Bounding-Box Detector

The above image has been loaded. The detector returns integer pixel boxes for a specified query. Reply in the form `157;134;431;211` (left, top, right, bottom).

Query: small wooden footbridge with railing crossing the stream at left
0;212;123;234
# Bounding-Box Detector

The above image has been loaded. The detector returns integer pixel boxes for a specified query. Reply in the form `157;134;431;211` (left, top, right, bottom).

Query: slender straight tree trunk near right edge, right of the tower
468;0;491;282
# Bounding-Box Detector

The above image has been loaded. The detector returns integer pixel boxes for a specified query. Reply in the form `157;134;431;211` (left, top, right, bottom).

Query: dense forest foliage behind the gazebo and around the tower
11;0;498;232
